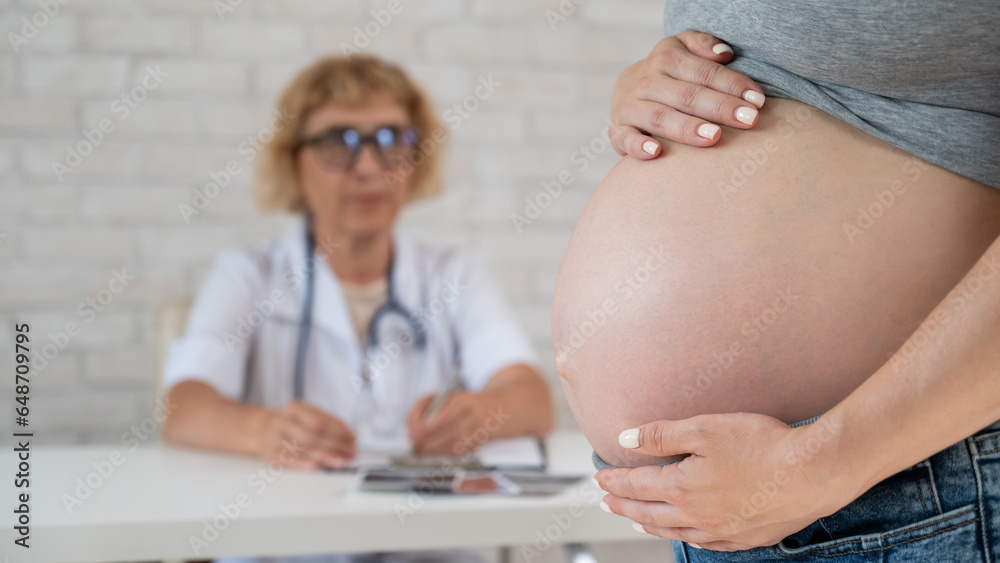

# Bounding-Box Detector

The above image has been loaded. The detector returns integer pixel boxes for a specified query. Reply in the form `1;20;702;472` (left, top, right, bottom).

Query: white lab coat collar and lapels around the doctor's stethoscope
276;219;427;350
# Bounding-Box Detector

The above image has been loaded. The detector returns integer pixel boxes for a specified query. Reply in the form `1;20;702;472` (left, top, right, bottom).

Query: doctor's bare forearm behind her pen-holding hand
479;365;555;438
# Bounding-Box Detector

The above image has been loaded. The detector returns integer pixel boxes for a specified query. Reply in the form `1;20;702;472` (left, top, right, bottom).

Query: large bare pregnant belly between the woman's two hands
552;99;1000;465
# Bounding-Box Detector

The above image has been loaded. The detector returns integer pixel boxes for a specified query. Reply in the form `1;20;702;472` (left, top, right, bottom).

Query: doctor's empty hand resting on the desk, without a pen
260;401;357;471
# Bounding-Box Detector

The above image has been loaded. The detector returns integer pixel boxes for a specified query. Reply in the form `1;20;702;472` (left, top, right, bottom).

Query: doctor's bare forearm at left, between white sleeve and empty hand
163;380;271;455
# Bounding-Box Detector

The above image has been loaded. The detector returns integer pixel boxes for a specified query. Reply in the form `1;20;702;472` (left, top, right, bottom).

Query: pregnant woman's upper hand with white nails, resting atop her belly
609;29;764;160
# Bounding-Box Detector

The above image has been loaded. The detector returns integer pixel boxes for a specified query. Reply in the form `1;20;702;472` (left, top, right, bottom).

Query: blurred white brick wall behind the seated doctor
0;0;662;454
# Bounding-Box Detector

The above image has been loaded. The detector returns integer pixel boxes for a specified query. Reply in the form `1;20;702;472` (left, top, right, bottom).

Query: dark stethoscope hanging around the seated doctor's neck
293;218;427;400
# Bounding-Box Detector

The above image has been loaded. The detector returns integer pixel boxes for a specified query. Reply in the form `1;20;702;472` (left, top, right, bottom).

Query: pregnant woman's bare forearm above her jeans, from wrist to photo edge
806;239;1000;499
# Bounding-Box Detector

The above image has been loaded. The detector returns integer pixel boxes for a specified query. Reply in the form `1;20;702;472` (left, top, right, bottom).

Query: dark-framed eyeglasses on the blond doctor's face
295;125;417;172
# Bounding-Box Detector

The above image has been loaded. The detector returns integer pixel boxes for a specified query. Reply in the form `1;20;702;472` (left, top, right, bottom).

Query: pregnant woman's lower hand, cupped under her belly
595;413;854;551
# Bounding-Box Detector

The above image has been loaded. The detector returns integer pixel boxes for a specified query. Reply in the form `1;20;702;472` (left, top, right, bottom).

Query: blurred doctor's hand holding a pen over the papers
407;391;489;456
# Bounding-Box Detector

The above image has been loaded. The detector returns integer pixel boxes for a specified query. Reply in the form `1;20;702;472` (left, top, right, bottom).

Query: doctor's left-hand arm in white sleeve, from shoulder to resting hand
163;251;354;470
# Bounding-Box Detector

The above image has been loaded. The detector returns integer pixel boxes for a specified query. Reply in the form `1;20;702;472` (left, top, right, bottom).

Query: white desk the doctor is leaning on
0;433;655;563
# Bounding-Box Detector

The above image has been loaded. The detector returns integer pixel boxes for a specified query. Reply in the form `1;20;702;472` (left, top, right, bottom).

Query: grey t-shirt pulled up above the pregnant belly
664;0;1000;188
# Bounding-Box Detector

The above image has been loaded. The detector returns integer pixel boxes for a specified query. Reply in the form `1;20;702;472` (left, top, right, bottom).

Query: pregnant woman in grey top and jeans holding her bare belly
553;0;1000;562
